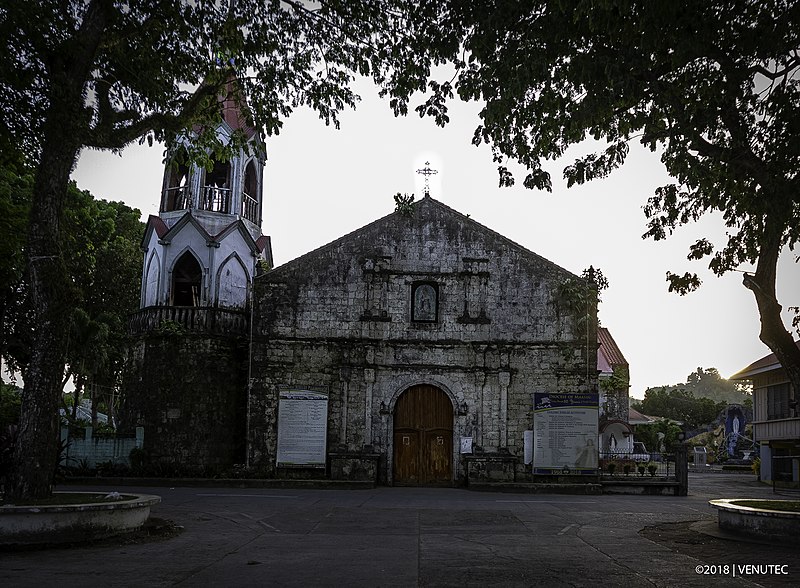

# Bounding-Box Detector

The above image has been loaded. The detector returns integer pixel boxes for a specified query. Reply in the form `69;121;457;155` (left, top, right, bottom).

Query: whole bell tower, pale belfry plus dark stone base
120;78;272;474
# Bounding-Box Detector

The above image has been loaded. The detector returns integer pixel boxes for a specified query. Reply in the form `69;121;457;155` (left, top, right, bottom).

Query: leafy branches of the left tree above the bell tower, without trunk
0;0;438;160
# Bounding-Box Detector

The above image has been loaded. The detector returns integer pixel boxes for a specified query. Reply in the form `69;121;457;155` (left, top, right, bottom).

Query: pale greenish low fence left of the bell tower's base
61;427;144;468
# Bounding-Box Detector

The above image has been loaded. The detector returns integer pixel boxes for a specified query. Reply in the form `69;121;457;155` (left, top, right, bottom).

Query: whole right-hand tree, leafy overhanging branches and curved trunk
418;0;800;398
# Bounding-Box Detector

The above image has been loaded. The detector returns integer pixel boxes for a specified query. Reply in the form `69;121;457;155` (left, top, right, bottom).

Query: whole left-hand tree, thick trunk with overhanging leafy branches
0;0;432;500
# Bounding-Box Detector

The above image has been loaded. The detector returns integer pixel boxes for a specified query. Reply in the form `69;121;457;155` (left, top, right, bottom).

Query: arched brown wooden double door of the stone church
393;385;453;486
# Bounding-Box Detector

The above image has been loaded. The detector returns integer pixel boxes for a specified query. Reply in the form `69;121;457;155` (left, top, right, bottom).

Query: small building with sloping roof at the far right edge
729;341;800;484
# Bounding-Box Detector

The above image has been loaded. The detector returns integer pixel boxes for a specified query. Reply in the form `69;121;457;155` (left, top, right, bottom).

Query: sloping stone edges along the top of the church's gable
270;196;582;279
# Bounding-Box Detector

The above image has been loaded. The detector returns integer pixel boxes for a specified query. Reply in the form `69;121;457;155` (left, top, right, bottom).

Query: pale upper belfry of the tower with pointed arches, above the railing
141;81;272;309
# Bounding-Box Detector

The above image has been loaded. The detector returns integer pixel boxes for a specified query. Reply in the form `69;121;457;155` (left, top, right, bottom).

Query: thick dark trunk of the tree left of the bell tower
6;0;110;502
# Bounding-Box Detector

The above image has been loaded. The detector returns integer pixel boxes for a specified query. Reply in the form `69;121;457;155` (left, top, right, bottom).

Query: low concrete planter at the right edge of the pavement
708;498;800;543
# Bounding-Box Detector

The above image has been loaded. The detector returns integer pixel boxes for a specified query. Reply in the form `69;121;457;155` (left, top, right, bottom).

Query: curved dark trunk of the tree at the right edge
743;223;800;399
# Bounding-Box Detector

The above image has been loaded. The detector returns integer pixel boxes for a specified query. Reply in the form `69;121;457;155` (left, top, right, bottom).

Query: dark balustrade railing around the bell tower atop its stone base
128;306;248;337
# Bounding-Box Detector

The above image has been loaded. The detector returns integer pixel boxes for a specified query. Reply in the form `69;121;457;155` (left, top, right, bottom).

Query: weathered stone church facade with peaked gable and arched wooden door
247;196;597;485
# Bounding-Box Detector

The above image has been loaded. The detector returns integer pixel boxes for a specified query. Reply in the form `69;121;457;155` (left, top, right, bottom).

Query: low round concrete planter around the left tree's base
0;492;161;545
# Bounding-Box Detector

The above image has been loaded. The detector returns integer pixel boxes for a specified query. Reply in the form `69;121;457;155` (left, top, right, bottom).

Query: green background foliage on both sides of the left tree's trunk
0;161;144;424
